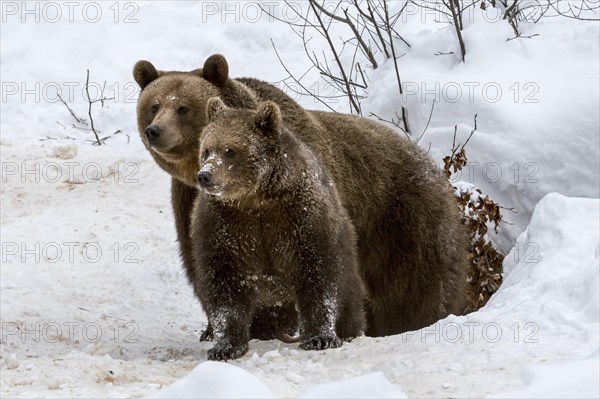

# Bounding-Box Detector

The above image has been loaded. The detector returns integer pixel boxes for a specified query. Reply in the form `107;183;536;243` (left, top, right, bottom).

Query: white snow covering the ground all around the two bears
0;1;600;397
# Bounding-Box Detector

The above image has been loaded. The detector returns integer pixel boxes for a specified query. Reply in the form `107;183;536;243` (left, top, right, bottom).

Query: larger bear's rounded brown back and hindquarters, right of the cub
286;111;467;335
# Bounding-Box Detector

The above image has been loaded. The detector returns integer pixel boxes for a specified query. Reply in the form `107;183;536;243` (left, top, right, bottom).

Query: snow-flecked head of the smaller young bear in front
197;97;281;200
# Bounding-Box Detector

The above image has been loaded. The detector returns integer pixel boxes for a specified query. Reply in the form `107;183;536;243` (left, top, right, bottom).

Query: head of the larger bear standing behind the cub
133;54;255;186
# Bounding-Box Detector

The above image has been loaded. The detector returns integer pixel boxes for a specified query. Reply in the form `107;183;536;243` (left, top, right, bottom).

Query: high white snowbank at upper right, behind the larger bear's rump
364;16;600;253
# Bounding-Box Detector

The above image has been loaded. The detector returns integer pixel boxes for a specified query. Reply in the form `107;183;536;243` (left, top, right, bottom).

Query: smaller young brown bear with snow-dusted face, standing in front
192;97;365;360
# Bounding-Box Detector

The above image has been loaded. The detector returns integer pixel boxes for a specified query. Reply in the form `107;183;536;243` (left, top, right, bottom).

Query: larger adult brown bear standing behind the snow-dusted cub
134;55;468;337
